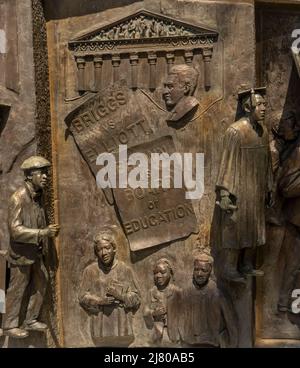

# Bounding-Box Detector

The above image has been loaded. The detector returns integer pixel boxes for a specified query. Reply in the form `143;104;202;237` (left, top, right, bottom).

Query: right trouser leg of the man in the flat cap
25;259;48;324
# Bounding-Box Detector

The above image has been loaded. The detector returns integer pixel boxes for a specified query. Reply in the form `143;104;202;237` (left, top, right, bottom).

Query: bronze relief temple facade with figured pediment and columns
68;9;218;94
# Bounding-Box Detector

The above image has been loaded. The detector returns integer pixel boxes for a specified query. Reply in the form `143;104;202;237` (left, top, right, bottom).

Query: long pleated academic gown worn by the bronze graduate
216;118;272;249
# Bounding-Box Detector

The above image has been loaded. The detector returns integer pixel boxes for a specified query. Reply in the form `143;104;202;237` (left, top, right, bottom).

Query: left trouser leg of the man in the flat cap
3;265;31;329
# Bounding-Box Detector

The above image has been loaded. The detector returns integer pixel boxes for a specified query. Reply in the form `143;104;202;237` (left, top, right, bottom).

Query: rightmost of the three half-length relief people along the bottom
180;251;238;347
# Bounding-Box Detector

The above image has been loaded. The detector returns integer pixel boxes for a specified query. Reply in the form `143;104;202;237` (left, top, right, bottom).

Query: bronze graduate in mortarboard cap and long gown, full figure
216;88;272;282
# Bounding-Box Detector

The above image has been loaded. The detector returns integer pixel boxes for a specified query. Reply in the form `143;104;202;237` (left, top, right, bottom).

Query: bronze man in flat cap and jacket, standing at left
3;156;59;338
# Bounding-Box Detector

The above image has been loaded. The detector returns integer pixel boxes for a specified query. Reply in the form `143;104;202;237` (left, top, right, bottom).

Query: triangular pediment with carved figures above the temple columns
69;10;218;52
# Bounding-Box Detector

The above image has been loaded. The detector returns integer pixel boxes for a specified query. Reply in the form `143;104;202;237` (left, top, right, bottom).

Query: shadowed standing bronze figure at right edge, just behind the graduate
263;109;300;314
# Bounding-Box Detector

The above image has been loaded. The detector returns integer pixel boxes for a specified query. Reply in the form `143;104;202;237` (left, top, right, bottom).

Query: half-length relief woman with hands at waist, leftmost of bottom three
79;230;141;346
